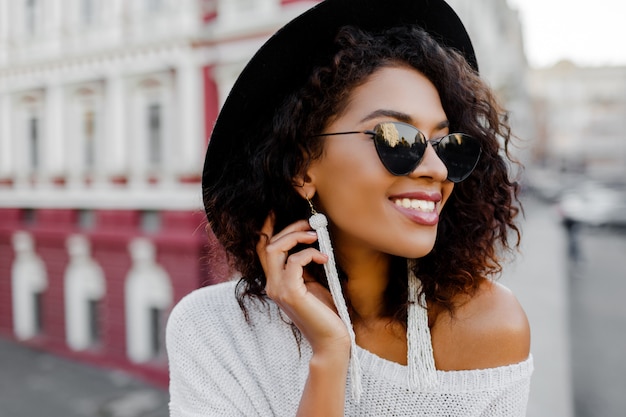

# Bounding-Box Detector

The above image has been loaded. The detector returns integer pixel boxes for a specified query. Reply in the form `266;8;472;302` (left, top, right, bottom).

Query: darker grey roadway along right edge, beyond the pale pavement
569;224;626;417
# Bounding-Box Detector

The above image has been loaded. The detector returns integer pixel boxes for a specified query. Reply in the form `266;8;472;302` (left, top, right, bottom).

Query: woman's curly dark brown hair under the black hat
204;26;521;319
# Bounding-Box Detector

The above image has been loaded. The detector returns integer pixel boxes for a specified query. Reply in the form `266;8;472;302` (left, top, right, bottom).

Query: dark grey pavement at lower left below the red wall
0;338;168;417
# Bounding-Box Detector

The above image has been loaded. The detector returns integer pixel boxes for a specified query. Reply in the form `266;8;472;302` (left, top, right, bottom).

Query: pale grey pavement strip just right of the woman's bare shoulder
500;196;574;417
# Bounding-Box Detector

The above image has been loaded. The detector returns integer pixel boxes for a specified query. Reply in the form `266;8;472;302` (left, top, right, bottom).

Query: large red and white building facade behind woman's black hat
0;0;530;385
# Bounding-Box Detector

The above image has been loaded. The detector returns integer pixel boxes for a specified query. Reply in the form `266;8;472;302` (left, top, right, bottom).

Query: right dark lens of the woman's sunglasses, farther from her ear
437;133;482;182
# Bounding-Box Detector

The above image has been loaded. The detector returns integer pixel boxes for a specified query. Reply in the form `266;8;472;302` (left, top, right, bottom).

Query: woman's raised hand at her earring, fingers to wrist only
256;214;350;356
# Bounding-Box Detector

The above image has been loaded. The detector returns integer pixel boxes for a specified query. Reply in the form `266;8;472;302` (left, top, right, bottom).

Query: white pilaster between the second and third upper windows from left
102;74;128;181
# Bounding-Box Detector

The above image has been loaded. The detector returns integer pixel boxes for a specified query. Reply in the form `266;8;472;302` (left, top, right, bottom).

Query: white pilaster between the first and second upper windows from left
40;84;67;180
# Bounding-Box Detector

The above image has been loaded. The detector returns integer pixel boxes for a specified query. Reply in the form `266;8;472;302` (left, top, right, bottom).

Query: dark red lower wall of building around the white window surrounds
0;209;229;387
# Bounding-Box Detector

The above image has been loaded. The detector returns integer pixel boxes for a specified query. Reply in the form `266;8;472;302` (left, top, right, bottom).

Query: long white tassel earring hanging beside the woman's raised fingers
307;198;362;402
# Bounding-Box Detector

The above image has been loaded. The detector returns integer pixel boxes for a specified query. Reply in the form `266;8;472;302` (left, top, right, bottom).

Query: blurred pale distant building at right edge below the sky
530;61;626;185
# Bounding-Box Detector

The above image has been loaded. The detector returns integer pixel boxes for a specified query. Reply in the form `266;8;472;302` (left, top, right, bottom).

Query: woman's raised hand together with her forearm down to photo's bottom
256;214;350;417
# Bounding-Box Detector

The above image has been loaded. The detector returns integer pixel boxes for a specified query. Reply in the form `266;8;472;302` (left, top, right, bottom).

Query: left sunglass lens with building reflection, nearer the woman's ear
374;122;427;175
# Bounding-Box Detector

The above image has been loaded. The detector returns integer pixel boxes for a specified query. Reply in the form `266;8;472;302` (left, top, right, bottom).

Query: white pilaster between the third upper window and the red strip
172;59;204;175
